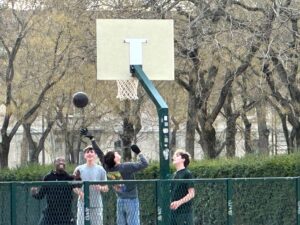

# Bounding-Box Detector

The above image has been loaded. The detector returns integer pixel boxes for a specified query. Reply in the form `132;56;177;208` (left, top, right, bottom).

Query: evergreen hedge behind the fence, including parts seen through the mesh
0;153;300;225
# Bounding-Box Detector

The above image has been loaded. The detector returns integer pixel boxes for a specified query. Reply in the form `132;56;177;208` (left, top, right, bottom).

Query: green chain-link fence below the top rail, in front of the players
0;177;300;225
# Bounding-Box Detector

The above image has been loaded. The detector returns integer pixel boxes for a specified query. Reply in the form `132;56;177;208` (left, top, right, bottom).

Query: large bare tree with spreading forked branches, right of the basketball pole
172;1;275;158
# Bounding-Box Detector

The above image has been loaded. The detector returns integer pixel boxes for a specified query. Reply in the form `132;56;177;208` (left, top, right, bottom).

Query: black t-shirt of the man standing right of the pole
171;168;194;214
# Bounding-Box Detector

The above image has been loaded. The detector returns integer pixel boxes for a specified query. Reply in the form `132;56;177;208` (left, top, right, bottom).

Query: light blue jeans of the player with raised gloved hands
117;198;140;225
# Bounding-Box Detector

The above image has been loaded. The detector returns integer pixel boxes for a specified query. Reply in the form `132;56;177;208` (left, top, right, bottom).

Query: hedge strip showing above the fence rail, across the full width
0;153;300;181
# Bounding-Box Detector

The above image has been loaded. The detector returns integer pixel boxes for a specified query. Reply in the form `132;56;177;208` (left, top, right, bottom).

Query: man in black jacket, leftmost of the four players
31;157;80;225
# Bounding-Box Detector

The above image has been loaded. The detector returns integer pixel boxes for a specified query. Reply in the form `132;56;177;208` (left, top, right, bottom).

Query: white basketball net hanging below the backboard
117;77;139;101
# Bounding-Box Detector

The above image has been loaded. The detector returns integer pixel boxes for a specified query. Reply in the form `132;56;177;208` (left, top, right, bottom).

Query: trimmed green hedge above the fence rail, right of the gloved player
138;153;300;179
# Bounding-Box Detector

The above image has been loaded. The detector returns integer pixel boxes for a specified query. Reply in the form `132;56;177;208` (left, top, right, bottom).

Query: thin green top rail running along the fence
0;176;300;186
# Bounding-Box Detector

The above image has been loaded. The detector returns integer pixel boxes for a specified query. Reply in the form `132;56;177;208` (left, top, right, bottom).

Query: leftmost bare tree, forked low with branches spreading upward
0;2;72;168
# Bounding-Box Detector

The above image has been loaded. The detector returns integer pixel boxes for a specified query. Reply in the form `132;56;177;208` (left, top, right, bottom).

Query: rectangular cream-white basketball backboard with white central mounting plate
96;19;174;80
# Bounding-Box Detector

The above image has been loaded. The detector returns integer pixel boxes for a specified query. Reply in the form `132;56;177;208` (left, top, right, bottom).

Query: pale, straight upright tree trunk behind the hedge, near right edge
256;101;270;155
